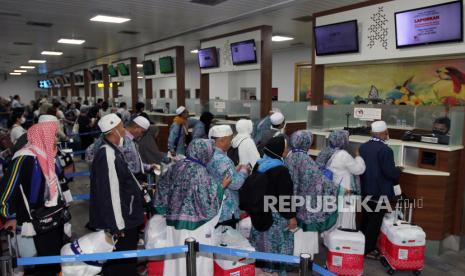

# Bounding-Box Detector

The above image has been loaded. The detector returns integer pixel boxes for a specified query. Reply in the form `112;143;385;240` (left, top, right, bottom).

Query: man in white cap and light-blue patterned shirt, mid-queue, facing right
207;125;249;228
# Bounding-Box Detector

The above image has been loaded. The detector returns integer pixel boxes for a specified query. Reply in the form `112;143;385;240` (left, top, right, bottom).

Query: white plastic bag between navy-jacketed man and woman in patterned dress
144;215;168;249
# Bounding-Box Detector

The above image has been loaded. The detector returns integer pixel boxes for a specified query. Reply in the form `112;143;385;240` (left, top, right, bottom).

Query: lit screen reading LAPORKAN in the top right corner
395;1;463;48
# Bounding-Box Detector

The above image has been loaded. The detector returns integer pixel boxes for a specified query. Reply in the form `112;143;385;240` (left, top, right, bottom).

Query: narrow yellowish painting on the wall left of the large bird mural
294;63;312;102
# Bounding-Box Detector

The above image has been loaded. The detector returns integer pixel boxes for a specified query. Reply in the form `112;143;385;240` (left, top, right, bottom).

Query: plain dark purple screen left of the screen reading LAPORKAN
313;20;358;56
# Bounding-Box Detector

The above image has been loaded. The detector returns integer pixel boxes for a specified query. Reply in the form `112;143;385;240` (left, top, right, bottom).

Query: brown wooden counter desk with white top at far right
310;129;463;241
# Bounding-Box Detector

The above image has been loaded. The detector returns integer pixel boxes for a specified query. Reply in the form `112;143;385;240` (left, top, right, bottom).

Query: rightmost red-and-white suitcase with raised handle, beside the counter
378;205;426;275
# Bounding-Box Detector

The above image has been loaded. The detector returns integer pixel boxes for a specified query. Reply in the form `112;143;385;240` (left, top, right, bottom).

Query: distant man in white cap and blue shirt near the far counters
168;106;189;156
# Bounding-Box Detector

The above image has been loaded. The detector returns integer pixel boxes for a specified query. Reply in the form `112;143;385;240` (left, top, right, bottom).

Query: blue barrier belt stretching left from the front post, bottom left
17;245;187;266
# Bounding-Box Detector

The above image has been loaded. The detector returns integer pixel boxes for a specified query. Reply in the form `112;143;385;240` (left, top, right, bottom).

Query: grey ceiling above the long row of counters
0;0;363;74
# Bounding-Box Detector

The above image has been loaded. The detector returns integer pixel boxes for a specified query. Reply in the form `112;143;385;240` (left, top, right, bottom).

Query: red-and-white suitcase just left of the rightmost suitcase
325;228;365;276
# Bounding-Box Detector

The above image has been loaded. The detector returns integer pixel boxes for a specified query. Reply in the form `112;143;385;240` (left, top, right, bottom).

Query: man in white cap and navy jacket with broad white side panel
89;114;144;275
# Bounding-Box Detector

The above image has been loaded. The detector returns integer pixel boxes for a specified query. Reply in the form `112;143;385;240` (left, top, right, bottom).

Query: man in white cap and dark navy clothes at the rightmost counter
359;121;401;259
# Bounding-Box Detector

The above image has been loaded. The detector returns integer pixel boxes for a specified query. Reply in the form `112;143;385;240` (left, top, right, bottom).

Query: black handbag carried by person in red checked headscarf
19;185;71;234
